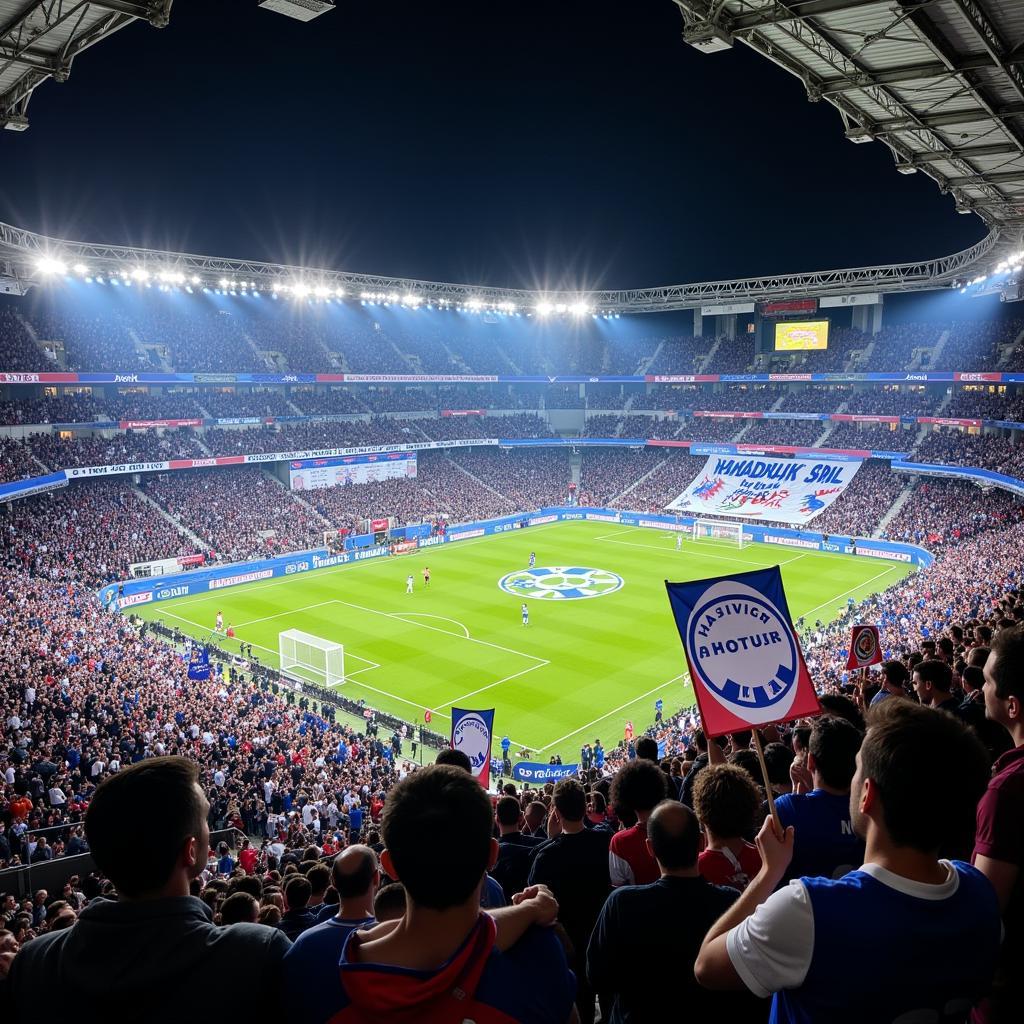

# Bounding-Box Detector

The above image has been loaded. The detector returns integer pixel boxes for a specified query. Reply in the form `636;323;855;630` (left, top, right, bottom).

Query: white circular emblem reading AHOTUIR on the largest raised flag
686;580;800;725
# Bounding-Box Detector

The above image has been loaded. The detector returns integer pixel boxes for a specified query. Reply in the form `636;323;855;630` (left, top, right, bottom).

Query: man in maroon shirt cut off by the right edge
972;626;1024;1024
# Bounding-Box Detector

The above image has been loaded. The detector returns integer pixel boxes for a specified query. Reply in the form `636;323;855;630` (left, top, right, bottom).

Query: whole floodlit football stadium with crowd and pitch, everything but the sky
0;0;1024;1024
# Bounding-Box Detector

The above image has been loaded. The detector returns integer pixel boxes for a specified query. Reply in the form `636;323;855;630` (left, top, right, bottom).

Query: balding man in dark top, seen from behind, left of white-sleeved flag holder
587;802;765;1024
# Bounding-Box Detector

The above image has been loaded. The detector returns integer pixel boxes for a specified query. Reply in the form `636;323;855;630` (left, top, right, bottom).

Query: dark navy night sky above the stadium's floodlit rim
0;0;985;288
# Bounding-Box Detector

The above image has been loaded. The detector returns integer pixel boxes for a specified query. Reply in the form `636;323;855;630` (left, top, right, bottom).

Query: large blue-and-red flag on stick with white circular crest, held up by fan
666;566;820;736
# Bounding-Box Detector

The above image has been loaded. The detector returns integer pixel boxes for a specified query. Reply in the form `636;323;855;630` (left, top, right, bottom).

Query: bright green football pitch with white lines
133;522;912;760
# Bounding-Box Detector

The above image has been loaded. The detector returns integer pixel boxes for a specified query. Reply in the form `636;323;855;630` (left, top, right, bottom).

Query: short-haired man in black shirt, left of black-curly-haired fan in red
529;769;606;1024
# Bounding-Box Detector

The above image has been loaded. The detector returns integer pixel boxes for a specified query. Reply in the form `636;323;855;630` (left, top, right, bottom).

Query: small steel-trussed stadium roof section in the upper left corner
0;0;174;131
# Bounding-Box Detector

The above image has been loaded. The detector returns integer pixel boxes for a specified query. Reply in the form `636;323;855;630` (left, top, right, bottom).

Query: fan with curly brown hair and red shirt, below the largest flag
693;765;761;892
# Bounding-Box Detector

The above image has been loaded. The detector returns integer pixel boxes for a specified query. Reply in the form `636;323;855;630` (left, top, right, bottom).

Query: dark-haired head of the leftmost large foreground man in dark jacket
85;757;210;899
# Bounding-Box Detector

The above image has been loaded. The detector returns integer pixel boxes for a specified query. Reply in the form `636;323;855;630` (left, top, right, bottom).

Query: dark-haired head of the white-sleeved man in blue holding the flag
850;700;989;855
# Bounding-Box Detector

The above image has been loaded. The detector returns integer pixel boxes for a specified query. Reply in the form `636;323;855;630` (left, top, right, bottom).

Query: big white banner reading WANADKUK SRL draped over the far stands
668;455;861;526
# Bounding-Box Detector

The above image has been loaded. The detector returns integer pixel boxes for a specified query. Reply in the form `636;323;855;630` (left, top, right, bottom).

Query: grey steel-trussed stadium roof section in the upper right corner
675;0;1024;227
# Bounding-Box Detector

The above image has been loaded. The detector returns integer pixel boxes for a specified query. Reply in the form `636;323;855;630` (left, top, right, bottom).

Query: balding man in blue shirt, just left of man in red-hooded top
285;845;381;1024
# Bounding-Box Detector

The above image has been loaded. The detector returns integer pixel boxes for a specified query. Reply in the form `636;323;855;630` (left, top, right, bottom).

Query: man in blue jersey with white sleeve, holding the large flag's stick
695;700;1001;1024
